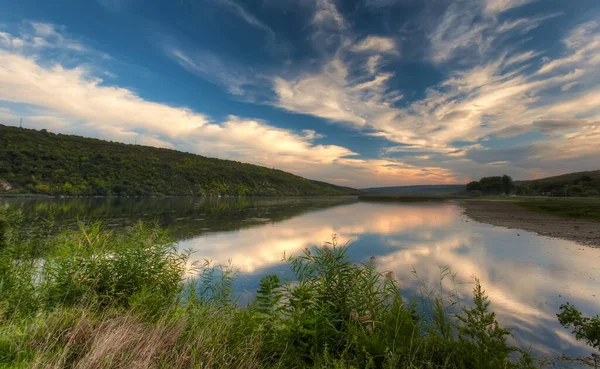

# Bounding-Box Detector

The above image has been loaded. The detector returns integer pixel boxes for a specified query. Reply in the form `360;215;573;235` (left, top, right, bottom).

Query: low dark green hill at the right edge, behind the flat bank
514;170;600;196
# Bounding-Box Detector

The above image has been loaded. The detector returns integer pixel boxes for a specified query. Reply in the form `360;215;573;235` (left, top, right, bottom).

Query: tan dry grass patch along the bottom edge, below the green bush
22;309;262;369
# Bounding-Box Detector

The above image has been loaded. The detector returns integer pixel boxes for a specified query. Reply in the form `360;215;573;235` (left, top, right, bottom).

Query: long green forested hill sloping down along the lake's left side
0;125;358;196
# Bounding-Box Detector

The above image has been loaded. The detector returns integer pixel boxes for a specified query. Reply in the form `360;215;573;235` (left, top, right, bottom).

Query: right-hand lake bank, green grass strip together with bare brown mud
459;199;600;247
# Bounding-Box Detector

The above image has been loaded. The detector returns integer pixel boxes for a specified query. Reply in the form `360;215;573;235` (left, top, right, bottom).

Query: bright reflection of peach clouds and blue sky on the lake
181;203;600;355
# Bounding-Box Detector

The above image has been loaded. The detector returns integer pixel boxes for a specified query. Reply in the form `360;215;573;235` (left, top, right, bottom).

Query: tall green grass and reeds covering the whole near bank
0;208;532;368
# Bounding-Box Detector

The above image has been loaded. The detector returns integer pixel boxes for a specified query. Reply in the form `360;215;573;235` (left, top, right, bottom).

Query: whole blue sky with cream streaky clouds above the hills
0;0;600;188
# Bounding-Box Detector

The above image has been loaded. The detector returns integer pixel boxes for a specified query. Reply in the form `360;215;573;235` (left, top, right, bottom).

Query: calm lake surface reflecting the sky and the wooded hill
4;198;600;356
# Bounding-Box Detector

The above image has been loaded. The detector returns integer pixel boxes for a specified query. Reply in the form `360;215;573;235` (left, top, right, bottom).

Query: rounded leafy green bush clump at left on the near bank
40;223;187;311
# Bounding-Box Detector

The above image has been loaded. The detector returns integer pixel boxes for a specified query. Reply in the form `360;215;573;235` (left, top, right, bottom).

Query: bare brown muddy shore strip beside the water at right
460;200;600;247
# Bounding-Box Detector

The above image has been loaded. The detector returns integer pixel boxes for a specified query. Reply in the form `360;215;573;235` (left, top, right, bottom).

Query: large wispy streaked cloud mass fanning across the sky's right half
273;7;600;178
